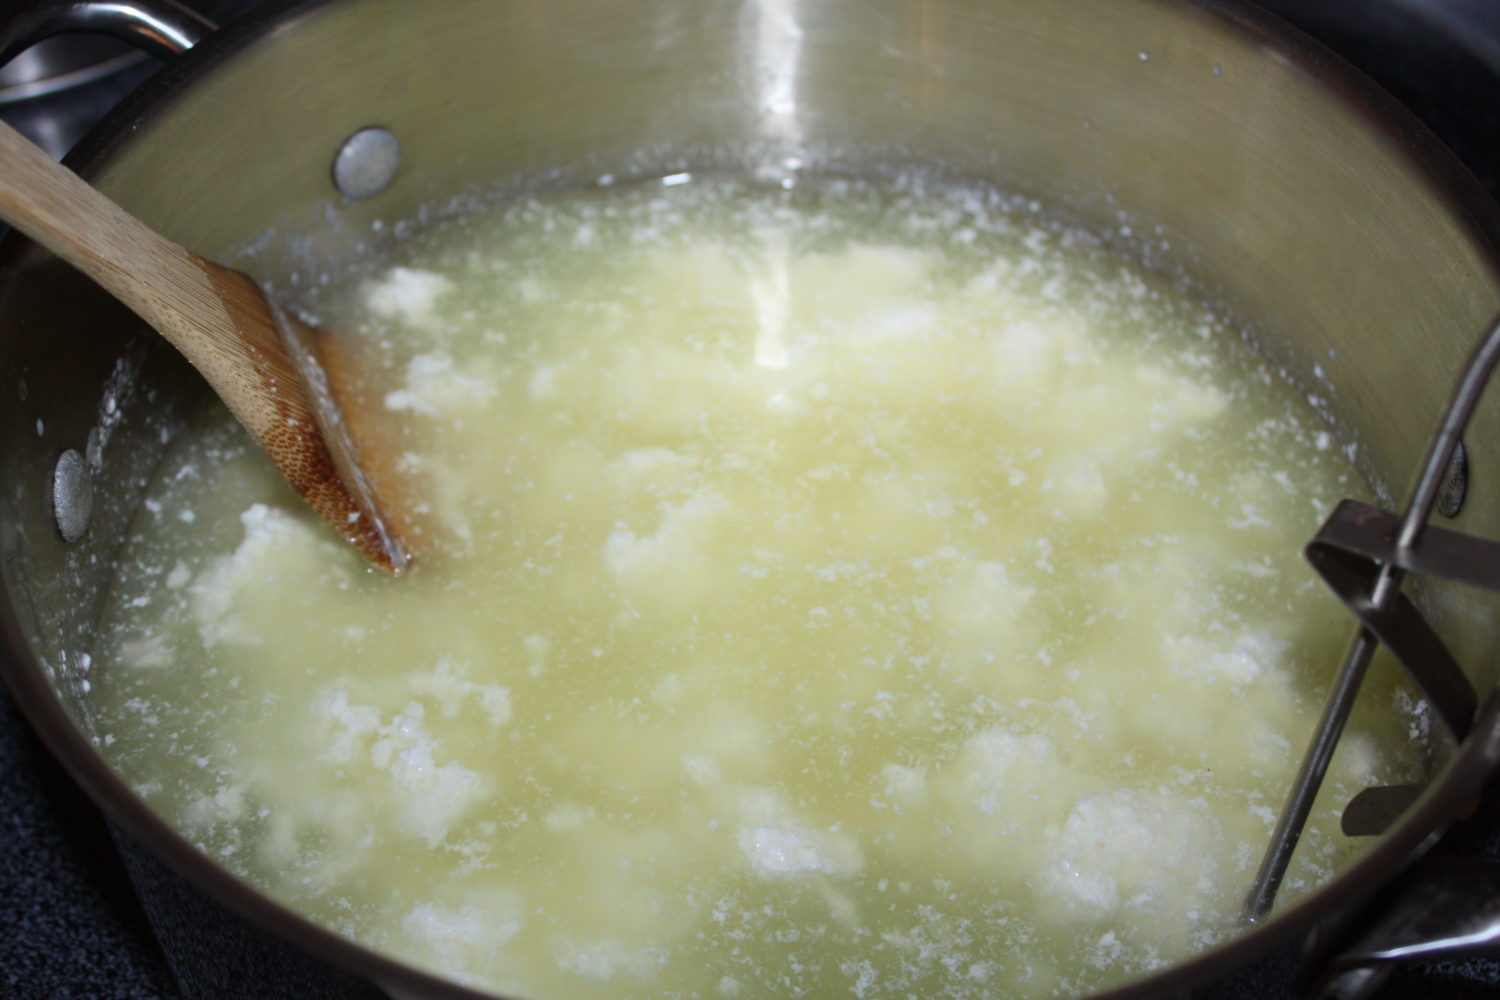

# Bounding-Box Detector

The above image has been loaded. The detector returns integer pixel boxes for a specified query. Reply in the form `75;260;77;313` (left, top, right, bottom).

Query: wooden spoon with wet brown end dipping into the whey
0;121;410;574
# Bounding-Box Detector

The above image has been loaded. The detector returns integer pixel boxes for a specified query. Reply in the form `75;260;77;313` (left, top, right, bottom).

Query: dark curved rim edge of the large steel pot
0;0;1500;1000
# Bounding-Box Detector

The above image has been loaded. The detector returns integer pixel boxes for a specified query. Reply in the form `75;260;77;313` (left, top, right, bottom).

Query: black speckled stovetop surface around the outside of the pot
0;0;1500;1000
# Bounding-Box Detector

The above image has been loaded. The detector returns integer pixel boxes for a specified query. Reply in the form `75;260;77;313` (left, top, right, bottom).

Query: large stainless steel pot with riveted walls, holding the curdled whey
0;0;1500;999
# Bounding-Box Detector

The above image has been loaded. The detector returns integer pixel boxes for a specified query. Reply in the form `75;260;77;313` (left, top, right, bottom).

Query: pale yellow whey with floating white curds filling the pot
90;175;1421;1000
